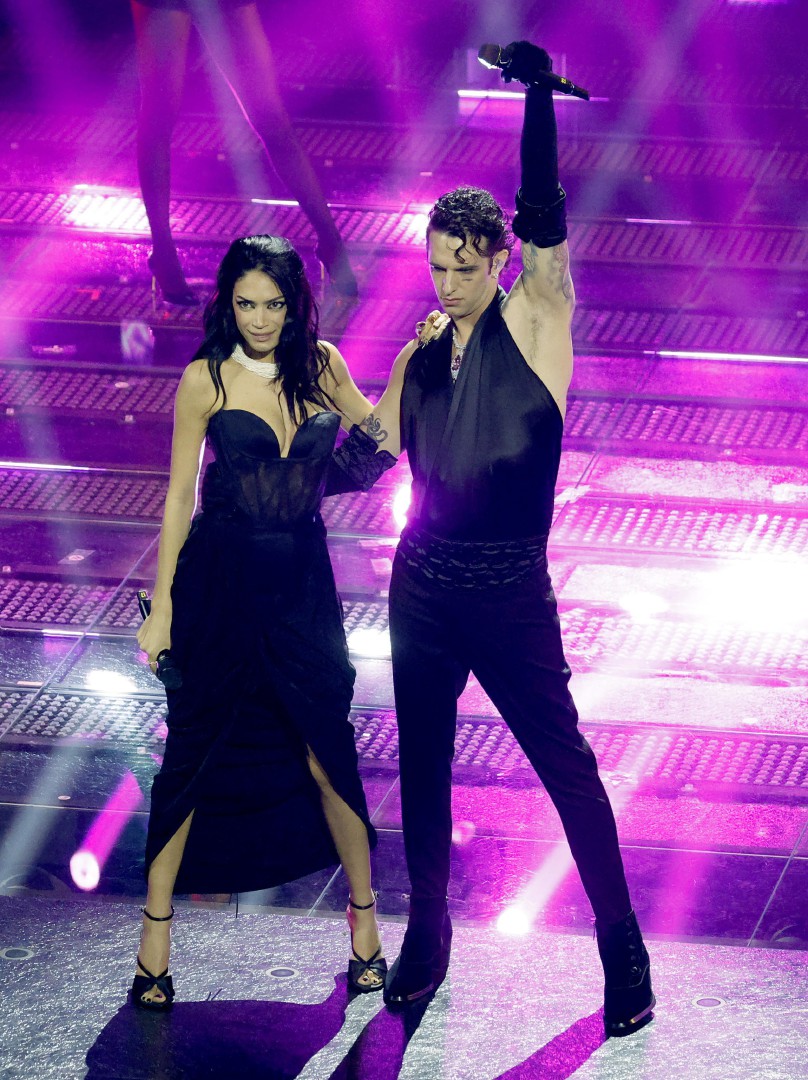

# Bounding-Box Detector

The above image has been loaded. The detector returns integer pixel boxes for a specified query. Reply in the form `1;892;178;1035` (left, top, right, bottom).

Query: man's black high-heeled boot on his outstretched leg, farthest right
595;912;657;1038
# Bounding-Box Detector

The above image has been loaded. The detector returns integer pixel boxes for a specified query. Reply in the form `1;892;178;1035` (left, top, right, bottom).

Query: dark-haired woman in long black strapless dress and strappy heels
132;235;393;1009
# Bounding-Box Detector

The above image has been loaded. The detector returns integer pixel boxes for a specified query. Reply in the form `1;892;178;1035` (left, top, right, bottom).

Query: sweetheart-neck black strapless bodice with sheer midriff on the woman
202;408;339;530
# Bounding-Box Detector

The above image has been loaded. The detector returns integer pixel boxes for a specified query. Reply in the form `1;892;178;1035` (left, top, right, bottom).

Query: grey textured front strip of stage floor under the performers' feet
0;897;808;1080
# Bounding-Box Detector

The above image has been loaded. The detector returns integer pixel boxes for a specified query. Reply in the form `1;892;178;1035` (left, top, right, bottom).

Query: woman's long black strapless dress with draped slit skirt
146;408;376;892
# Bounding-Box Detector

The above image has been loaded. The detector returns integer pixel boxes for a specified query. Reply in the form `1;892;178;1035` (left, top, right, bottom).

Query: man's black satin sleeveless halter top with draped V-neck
401;289;564;542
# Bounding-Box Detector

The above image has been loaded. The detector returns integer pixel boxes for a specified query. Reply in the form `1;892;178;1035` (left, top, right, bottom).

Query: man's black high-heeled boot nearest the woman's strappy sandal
385;899;452;1009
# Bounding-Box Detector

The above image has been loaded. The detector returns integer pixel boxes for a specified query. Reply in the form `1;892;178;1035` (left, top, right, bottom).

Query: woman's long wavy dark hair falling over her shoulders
192;235;334;423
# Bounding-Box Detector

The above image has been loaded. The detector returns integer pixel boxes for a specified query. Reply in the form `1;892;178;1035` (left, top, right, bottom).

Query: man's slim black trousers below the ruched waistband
390;553;631;922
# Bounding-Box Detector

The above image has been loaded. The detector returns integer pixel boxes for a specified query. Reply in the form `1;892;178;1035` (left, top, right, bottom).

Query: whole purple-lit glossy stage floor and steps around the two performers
0;0;808;1080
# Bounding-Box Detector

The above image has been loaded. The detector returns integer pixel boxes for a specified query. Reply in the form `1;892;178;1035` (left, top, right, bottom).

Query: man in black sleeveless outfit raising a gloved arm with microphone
328;42;655;1036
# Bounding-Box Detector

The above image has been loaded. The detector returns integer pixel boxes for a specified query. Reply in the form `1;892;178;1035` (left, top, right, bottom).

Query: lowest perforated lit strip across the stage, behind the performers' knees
3;691;808;801
